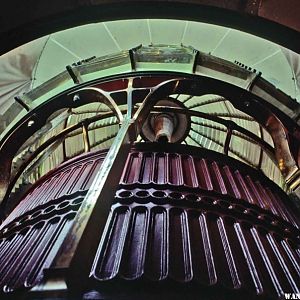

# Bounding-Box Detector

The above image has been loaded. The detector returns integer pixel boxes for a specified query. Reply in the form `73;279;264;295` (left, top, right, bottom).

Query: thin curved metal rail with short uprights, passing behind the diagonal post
0;106;276;214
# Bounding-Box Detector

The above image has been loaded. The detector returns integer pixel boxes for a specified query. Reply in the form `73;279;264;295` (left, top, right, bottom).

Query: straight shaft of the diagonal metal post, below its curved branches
32;119;133;293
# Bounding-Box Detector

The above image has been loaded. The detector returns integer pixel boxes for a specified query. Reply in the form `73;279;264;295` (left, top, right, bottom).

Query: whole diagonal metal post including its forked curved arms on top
31;79;185;296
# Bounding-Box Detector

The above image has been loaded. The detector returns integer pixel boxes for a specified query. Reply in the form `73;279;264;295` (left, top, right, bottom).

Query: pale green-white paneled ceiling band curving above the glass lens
0;19;300;114
